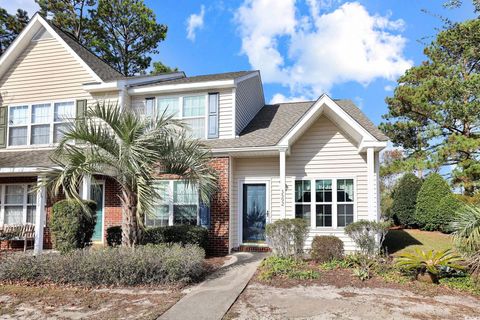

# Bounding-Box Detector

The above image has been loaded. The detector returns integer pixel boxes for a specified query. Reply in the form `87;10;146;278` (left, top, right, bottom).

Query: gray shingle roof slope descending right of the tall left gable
47;21;125;81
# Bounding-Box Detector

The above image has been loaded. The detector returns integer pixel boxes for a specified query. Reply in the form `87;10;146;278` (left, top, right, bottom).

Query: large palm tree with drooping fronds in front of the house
46;103;216;246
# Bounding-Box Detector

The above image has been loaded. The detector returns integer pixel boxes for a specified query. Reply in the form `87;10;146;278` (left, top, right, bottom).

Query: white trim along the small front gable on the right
278;94;378;147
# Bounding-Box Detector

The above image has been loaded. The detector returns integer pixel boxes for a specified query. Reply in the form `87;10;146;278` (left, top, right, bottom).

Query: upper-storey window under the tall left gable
8;101;76;146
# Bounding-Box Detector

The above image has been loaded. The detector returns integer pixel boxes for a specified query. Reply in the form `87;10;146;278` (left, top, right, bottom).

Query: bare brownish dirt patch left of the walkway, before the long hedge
0;285;183;319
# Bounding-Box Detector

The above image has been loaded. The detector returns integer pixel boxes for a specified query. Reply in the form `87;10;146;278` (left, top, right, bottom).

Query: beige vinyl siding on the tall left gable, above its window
0;38;95;105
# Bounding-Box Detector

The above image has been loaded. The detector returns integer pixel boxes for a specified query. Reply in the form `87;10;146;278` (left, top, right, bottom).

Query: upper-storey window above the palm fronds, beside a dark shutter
145;94;208;139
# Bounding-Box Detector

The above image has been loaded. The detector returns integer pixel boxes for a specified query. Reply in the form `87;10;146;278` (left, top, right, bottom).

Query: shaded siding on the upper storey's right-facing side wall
235;76;265;135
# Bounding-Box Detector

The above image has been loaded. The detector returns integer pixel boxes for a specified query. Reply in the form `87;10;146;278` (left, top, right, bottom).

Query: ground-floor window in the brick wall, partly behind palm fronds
145;180;199;227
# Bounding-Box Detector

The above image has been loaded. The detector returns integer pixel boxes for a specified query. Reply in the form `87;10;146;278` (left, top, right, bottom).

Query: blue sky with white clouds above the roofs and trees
0;0;474;124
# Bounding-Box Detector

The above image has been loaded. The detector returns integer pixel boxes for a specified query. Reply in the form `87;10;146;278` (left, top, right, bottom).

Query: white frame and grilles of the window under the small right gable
293;176;358;230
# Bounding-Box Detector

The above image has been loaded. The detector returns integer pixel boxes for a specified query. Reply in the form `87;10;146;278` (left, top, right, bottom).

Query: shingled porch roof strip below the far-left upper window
0;149;54;168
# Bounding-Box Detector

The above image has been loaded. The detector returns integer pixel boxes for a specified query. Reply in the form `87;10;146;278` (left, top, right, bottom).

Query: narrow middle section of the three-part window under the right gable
315;180;332;227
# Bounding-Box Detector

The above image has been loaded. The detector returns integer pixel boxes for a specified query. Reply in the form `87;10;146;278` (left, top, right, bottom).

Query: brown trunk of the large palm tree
121;190;140;247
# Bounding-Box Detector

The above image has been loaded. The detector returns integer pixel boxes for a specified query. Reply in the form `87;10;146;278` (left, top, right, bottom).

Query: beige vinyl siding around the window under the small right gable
286;116;368;251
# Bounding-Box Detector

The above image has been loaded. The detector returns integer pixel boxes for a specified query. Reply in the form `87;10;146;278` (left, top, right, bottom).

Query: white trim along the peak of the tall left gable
0;13;103;82
